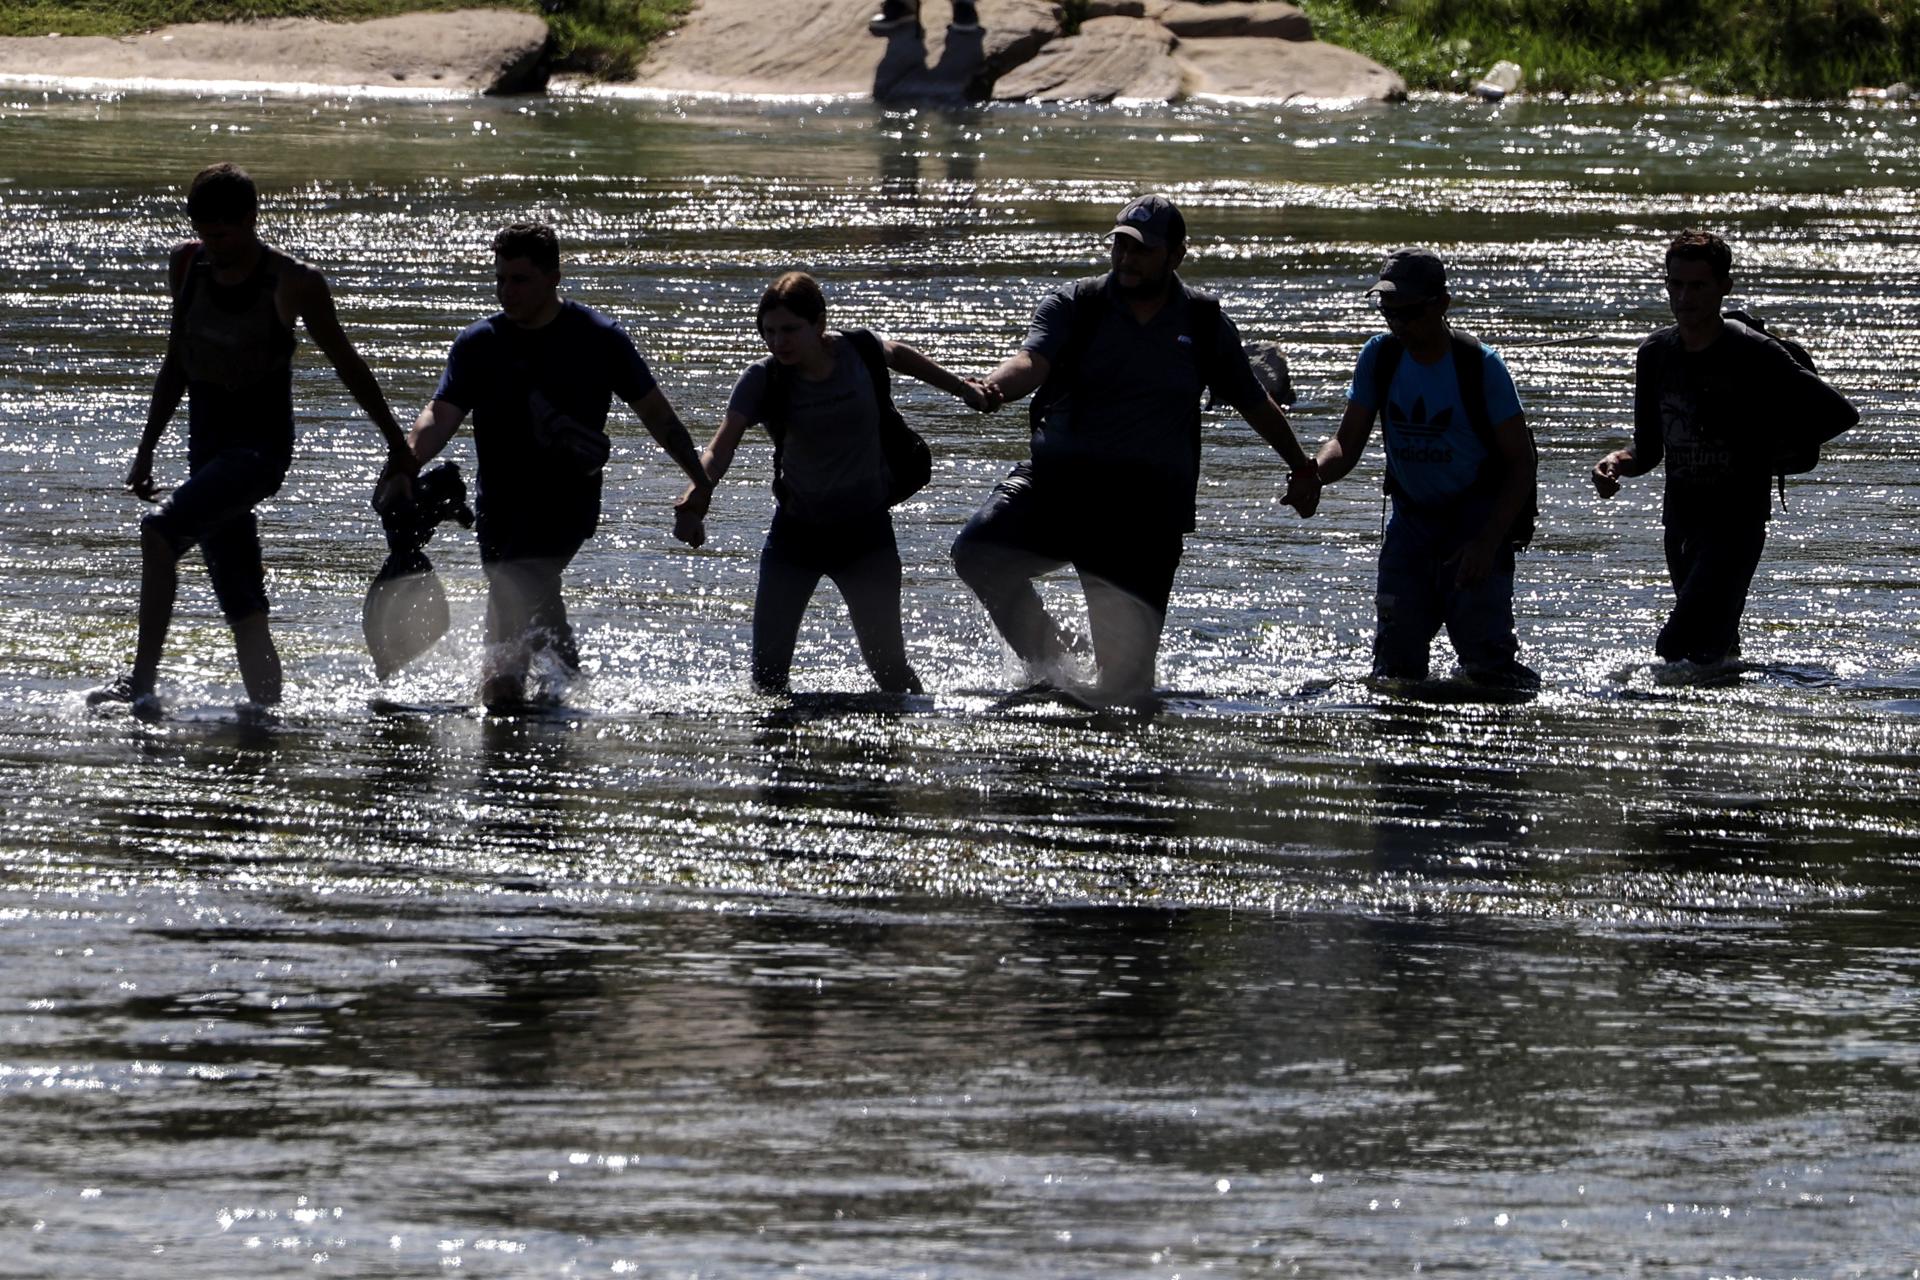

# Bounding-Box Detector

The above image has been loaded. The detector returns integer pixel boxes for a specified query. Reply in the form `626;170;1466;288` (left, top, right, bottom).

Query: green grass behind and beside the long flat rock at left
0;0;691;79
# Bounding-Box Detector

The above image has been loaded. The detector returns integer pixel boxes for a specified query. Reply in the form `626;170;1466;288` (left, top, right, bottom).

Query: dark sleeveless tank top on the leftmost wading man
173;249;296;470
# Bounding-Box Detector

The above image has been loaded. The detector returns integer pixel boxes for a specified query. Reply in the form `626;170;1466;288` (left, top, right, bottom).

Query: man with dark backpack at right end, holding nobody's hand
1594;230;1860;664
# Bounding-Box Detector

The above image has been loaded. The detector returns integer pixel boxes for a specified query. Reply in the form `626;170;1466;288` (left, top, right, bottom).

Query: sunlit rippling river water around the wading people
0;88;1920;1278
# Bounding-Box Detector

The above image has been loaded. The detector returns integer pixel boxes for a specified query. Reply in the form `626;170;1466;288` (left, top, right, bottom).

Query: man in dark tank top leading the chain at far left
86;165;419;718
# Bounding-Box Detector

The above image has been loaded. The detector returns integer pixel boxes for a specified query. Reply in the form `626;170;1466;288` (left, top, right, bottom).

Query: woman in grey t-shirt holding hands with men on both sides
674;271;987;693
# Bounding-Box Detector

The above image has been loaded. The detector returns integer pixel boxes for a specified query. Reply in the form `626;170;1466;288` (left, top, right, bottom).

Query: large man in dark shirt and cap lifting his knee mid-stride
952;196;1319;704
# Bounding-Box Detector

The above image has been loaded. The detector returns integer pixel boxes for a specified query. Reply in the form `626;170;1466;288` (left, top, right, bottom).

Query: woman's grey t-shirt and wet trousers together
728;330;920;693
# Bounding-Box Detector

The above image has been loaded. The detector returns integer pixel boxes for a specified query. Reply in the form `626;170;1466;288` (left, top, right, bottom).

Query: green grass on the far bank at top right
1294;0;1920;98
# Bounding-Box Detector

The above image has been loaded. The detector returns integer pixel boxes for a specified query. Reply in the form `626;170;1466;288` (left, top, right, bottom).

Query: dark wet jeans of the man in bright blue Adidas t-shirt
1373;499;1538;685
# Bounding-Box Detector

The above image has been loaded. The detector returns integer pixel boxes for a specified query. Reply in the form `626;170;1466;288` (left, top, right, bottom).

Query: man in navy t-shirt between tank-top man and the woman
409;223;712;710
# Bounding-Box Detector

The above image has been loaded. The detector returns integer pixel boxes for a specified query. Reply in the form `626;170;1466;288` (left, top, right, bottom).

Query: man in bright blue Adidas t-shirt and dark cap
1315;248;1540;689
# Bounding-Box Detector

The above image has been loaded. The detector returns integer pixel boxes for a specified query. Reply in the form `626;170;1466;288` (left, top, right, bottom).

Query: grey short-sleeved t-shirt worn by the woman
728;330;887;524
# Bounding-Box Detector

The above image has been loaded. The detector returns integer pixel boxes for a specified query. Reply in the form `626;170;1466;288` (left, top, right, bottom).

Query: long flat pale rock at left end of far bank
0;10;549;94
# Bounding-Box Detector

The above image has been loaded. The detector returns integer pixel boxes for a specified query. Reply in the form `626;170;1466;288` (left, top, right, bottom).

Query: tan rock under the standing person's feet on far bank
636;0;1066;98
